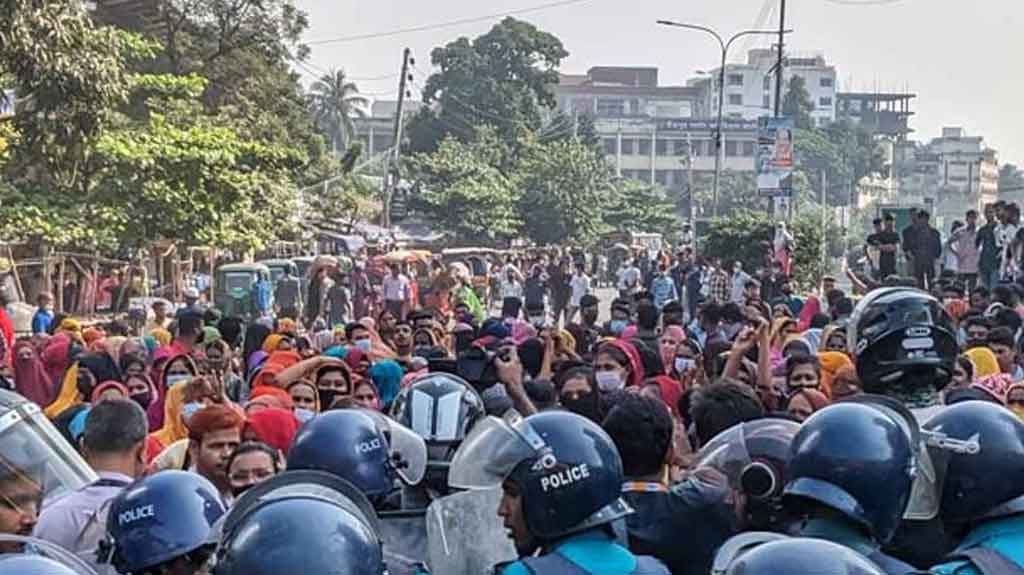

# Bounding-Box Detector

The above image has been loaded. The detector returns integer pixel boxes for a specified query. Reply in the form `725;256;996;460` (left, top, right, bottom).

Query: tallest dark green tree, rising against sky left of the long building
409;17;568;152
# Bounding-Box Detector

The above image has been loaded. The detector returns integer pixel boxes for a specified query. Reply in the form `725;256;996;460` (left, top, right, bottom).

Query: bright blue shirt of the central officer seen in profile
502;529;669;575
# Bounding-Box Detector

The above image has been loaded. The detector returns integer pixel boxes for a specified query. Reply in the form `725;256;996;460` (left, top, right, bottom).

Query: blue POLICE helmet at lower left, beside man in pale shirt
100;471;225;574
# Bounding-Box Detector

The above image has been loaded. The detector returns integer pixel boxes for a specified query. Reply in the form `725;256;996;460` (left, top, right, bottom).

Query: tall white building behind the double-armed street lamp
687;48;836;126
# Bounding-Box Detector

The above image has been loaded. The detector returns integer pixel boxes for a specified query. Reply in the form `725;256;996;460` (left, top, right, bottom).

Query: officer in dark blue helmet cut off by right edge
925;401;1024;575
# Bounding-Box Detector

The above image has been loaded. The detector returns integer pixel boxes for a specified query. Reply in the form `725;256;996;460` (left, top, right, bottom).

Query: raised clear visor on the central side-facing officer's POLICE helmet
449;416;544;489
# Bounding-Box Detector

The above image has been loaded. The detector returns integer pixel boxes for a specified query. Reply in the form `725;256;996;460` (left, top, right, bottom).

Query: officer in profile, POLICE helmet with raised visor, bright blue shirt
449;411;669;575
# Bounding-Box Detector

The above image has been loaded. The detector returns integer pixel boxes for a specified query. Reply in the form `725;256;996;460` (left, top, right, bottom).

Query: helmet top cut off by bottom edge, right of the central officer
711;533;886;575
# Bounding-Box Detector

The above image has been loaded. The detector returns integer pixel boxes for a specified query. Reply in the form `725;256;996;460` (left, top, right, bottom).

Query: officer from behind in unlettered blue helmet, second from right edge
782;403;916;575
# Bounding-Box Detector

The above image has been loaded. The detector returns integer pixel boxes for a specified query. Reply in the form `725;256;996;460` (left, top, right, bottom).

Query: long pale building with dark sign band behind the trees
553;67;757;212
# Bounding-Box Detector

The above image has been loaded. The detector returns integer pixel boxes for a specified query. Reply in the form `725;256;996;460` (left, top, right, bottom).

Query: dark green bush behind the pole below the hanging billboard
700;211;836;289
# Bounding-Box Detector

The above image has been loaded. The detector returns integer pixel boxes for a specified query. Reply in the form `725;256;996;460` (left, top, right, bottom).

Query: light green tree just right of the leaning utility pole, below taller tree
404;128;522;242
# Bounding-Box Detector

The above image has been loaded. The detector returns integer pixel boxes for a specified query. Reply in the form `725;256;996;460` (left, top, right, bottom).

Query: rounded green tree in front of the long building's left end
518;139;614;245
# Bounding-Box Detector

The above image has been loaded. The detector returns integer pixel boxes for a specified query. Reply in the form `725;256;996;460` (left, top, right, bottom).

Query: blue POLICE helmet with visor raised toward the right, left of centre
288;409;427;498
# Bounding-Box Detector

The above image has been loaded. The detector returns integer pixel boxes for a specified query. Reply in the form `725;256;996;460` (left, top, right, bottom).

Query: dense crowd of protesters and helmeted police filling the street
0;219;1024;575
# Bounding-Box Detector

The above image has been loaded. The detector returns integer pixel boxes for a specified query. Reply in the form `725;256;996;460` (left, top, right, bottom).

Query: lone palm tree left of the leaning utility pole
308;70;370;152
